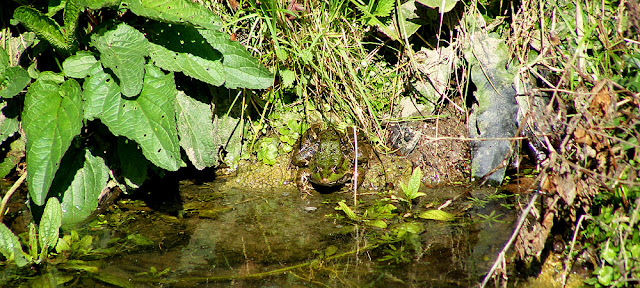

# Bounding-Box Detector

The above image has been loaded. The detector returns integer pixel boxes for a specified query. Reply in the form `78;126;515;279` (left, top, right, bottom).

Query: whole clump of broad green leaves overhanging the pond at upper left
0;0;273;224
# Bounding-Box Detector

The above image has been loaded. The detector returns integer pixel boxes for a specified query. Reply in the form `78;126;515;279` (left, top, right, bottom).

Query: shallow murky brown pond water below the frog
3;173;540;287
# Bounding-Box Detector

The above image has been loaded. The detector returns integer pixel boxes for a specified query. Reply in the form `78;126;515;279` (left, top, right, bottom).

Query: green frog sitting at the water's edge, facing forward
291;126;371;193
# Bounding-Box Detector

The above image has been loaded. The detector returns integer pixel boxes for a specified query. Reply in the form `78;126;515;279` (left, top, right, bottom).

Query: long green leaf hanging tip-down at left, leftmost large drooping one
22;79;83;206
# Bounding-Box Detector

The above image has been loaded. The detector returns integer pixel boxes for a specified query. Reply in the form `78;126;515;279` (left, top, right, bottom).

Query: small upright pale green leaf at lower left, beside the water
38;197;62;253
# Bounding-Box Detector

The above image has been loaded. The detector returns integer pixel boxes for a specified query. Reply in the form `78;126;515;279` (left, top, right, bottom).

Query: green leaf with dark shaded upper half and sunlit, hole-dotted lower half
143;23;224;86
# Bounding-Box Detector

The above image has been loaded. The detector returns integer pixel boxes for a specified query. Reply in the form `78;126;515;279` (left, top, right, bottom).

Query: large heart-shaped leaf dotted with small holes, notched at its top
83;65;182;171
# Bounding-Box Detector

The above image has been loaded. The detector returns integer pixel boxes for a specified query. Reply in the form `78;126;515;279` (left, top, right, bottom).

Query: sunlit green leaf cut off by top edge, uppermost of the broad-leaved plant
122;0;222;30
